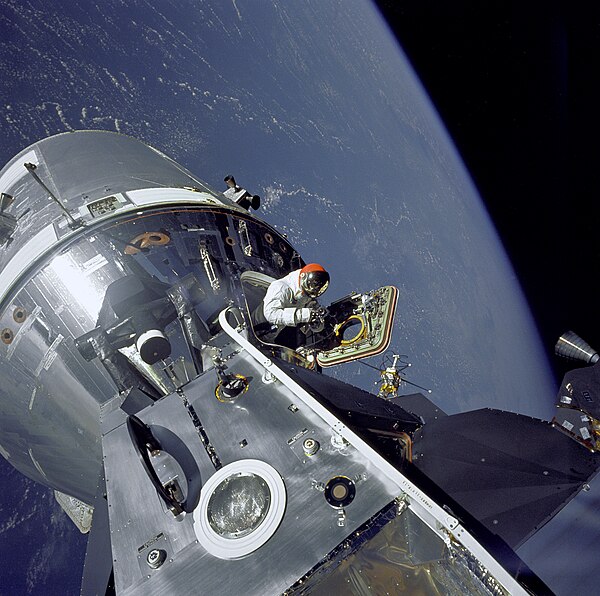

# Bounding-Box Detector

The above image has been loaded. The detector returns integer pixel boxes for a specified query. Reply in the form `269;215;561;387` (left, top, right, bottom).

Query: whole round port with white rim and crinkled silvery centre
194;459;286;559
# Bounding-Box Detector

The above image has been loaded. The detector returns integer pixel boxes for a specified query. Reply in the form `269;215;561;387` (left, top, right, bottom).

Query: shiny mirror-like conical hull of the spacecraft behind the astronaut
0;205;300;503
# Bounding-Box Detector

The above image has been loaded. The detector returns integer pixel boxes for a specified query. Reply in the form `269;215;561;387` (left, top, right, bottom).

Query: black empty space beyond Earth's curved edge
377;0;600;378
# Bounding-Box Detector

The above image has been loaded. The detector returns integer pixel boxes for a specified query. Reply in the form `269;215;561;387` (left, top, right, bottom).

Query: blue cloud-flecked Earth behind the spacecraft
0;0;600;594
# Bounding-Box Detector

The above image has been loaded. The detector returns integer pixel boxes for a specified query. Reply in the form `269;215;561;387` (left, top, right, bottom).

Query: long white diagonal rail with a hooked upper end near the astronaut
219;306;527;595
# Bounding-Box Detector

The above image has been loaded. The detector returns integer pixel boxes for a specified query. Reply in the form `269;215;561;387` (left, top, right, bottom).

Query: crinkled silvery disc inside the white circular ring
207;472;271;539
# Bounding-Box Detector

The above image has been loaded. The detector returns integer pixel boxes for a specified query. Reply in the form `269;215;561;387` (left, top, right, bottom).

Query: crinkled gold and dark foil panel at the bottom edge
285;506;508;596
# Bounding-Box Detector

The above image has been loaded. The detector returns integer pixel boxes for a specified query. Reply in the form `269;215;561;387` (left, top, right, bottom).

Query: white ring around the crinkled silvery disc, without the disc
193;459;286;559
